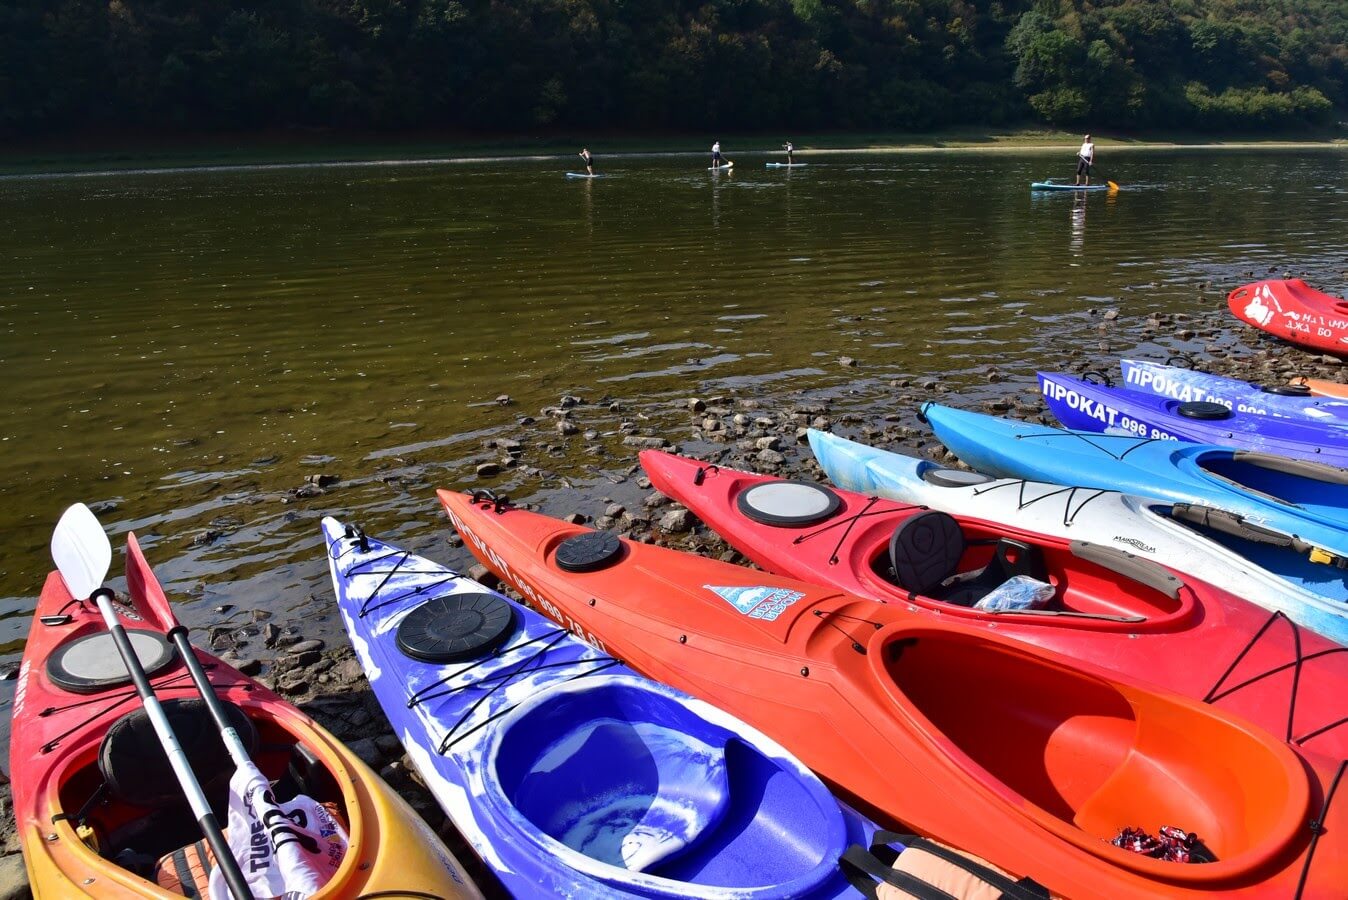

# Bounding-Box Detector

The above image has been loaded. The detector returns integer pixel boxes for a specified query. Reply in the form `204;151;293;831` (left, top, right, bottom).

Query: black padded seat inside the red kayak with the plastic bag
890;509;1047;606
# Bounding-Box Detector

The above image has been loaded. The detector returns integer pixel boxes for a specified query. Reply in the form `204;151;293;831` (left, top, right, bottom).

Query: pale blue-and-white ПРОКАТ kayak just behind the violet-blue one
1119;360;1348;424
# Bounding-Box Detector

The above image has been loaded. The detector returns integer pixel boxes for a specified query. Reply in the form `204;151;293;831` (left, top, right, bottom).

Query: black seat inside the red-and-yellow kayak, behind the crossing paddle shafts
98;697;257;810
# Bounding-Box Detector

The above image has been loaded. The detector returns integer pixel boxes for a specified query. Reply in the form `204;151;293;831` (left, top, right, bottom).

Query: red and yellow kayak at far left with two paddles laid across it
9;535;483;900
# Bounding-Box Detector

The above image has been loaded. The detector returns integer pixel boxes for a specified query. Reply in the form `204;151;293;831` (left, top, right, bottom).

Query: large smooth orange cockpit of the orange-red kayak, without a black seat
872;628;1309;881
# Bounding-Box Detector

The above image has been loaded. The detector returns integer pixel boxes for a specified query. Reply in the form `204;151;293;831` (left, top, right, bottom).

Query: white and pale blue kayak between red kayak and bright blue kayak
809;428;1348;644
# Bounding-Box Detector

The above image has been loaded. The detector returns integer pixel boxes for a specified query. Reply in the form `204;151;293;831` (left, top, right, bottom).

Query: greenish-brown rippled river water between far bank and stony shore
0;150;1348;738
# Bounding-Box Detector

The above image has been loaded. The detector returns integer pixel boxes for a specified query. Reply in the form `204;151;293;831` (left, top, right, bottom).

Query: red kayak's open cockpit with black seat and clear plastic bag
856;511;1193;631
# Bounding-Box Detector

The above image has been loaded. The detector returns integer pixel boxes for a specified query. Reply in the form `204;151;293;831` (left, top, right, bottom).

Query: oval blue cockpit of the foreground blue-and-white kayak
485;675;847;896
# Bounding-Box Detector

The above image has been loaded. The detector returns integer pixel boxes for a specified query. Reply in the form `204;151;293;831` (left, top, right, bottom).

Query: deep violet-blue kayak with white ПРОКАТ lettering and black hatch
1038;372;1348;466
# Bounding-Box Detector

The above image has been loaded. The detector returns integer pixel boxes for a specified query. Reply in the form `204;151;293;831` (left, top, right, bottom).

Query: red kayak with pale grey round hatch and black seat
642;450;1348;760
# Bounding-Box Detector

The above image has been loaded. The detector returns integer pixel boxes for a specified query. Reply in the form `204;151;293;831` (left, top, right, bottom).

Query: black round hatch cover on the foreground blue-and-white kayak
398;591;515;663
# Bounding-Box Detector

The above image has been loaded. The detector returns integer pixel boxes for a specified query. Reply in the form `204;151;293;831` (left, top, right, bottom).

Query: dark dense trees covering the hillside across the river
0;0;1348;133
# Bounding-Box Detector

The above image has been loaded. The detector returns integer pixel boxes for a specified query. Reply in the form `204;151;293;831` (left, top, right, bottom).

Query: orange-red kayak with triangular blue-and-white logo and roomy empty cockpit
439;490;1348;899
